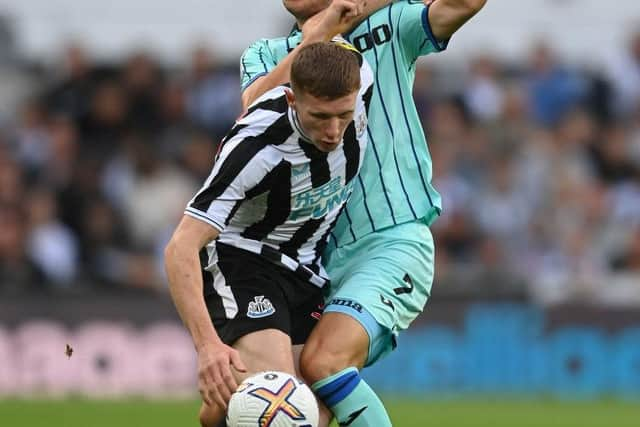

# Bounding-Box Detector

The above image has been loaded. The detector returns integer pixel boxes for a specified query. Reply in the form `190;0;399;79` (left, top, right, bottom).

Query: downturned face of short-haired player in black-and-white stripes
287;91;358;153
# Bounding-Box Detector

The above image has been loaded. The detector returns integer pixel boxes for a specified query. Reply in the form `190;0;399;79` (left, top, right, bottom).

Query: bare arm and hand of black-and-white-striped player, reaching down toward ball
165;215;246;408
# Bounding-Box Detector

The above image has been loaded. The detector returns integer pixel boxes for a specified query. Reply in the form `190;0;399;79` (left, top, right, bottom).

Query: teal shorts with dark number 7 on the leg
324;221;435;365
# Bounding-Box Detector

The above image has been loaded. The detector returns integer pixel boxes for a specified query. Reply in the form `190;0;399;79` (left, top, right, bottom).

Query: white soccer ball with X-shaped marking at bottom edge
227;371;318;427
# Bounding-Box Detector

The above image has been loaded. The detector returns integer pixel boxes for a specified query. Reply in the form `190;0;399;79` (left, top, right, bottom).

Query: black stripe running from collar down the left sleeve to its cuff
191;114;293;212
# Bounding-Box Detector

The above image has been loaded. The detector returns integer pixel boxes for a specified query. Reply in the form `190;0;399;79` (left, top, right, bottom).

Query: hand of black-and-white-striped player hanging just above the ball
198;342;247;409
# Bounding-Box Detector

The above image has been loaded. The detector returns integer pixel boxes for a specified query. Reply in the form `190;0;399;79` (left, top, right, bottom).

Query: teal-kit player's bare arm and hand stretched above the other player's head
242;0;391;108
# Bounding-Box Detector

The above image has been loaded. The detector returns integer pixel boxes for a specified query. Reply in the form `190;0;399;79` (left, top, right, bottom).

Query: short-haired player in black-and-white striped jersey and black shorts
165;41;373;426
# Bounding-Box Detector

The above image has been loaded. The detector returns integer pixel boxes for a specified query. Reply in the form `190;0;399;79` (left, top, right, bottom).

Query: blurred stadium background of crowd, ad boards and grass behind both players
0;0;640;427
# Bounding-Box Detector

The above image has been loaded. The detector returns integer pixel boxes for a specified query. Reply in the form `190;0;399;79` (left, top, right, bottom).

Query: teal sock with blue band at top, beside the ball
311;368;391;427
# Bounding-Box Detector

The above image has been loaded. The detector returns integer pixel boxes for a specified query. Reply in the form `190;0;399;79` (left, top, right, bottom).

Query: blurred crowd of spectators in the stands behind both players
0;34;640;304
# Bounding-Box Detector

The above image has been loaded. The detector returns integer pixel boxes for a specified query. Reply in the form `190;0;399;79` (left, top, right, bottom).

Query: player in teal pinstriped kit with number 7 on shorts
241;0;486;427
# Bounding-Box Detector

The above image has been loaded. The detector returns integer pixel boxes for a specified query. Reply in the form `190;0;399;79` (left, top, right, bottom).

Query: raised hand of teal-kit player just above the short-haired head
302;0;367;41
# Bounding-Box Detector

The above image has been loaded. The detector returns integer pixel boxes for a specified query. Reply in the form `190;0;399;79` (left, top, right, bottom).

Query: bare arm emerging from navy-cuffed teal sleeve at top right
424;0;487;40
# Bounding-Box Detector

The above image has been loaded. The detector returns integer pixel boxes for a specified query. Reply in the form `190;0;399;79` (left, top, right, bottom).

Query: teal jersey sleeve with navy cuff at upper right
394;0;448;63
